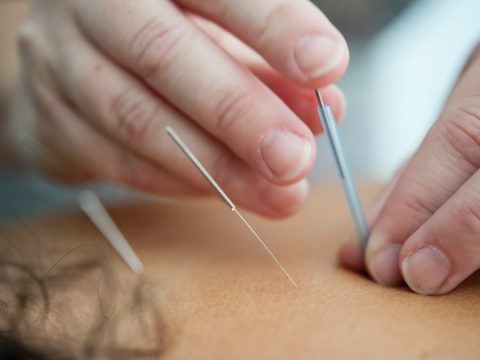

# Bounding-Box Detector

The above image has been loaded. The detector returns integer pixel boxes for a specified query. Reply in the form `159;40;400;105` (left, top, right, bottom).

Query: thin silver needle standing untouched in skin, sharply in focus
165;126;297;287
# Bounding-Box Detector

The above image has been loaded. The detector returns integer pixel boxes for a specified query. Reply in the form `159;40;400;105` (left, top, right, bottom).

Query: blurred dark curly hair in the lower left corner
0;229;166;360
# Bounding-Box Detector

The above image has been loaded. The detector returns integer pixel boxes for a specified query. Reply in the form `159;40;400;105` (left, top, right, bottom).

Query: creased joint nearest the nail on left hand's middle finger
213;90;253;134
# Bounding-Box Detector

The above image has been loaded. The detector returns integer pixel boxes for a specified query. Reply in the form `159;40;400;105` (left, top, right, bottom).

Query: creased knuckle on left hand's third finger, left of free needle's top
111;88;155;145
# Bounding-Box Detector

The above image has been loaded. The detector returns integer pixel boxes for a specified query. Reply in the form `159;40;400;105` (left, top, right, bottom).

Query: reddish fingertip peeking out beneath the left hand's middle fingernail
262;179;309;215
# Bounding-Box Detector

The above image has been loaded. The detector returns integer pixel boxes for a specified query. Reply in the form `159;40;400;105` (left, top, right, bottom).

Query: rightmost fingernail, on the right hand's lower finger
402;245;451;295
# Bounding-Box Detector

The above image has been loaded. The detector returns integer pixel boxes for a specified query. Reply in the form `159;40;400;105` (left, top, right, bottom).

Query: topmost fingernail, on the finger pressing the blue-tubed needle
294;35;345;79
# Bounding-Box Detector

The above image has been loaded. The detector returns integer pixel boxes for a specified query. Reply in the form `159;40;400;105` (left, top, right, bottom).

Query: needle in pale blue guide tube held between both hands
315;89;370;252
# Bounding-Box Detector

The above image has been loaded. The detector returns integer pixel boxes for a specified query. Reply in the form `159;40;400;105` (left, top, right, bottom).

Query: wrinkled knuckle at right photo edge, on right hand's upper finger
445;108;480;168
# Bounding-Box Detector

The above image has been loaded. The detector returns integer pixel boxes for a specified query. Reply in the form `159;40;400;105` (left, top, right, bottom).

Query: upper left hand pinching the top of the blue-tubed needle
7;0;348;216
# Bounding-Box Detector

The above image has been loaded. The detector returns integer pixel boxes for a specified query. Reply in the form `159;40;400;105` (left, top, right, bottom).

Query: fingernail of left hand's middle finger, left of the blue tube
260;129;312;181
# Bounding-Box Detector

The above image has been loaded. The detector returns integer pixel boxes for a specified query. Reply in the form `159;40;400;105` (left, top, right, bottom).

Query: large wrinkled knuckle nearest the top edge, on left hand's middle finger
129;19;186;78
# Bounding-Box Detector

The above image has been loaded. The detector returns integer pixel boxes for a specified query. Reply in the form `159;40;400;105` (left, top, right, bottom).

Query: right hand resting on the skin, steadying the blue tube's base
340;43;480;294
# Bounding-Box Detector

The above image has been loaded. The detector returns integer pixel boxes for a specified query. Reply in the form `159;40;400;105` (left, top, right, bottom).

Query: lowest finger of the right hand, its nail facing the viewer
400;171;480;295
